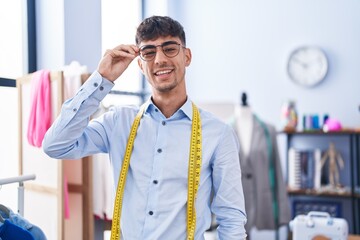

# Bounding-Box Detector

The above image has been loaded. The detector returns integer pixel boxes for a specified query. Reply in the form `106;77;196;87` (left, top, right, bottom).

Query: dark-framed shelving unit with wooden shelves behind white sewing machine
279;130;360;234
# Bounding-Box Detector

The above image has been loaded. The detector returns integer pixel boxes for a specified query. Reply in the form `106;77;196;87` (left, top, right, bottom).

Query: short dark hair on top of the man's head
135;16;186;46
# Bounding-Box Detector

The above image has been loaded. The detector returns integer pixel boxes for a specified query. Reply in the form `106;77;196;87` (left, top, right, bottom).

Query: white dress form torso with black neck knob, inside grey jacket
235;93;254;157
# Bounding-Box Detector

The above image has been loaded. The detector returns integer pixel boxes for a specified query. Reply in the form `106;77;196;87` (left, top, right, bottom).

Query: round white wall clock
287;47;328;87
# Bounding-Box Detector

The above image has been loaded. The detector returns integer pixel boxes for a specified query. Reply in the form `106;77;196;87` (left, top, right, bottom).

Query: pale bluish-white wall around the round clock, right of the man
169;0;360;127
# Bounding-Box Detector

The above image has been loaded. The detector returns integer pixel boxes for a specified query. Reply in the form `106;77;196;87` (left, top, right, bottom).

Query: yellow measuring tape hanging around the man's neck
111;103;202;240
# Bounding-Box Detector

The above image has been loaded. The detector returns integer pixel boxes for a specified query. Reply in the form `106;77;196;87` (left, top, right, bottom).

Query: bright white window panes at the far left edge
0;1;23;211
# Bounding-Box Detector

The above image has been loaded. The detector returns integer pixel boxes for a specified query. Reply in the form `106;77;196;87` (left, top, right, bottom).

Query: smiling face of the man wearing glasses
138;36;191;93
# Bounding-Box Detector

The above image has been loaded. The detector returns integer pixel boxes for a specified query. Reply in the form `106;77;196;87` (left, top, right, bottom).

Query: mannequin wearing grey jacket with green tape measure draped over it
233;93;291;239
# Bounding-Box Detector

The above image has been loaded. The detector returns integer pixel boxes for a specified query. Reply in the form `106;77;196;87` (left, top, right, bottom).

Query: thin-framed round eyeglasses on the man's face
140;41;185;61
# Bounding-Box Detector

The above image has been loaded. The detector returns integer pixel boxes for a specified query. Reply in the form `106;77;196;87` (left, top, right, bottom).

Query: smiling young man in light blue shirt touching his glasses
43;16;246;240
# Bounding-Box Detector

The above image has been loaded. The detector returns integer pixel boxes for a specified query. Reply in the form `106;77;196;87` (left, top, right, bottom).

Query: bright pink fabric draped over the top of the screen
27;70;51;147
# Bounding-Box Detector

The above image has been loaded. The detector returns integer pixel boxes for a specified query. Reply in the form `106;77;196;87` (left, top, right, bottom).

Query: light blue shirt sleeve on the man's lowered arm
211;125;246;240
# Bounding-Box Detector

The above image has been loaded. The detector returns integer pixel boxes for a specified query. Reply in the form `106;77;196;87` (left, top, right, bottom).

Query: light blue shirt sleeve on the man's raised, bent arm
42;71;114;159
